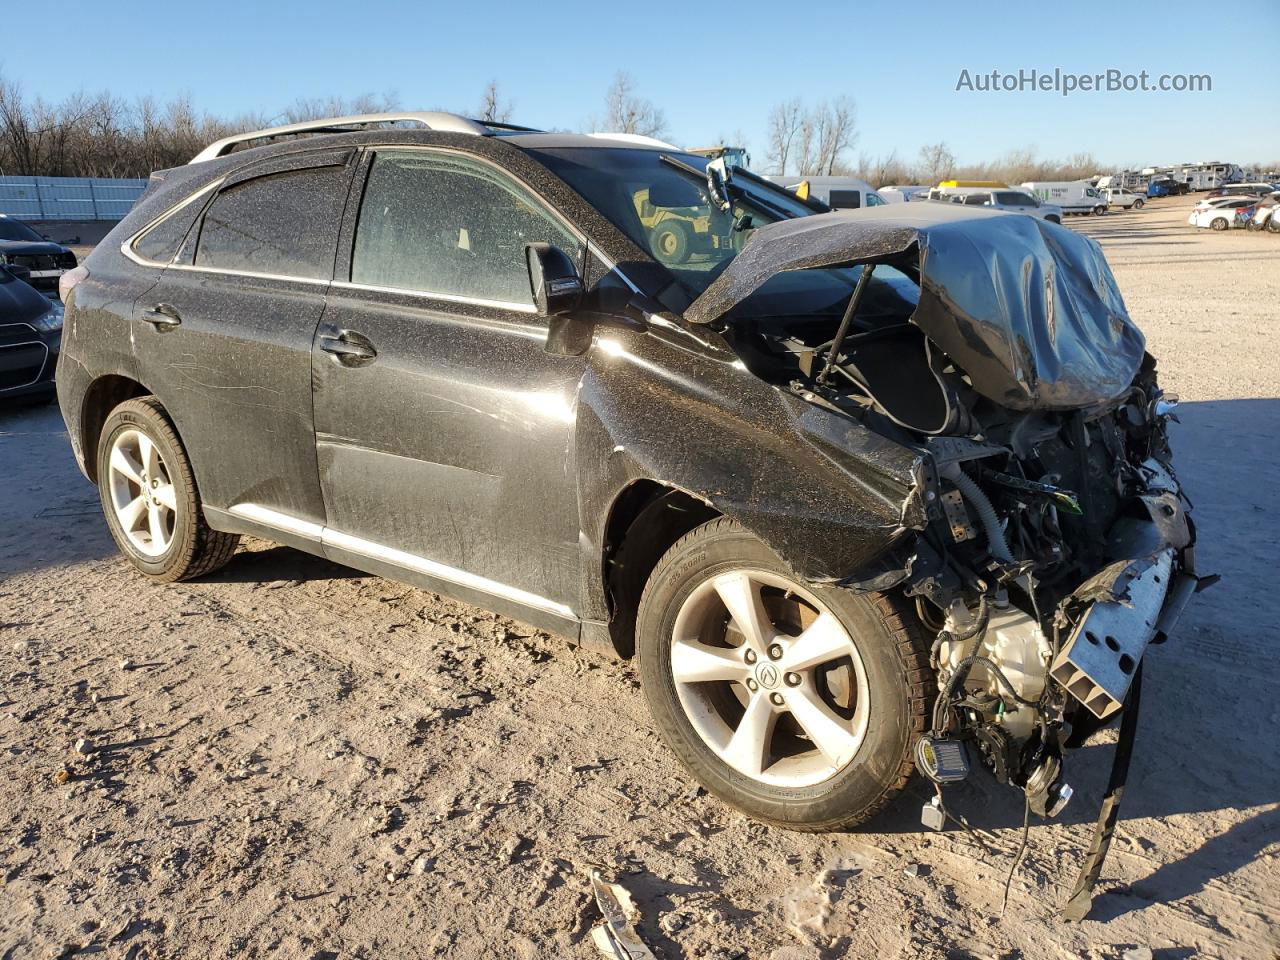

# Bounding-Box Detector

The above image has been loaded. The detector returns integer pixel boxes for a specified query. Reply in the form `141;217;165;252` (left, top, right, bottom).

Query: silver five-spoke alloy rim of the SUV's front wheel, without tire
671;570;870;787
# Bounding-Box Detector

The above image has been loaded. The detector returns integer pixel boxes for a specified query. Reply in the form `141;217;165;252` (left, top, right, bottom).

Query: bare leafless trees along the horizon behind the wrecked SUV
0;72;1274;187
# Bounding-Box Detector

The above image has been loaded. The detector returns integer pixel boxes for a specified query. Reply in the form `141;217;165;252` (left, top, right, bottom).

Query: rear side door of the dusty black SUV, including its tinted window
133;150;357;524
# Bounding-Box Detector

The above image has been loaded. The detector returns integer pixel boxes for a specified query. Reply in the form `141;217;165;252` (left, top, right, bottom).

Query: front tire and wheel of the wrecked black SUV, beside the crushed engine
636;517;936;832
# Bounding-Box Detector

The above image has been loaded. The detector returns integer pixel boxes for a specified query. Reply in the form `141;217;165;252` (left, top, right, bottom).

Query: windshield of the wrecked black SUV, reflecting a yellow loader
517;147;815;296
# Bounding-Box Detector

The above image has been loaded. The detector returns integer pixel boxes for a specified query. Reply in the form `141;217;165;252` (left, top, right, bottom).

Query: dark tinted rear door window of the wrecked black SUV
196;166;348;280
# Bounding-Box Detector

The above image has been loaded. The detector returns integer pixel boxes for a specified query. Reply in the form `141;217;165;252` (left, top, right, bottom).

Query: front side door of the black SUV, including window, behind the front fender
314;148;585;620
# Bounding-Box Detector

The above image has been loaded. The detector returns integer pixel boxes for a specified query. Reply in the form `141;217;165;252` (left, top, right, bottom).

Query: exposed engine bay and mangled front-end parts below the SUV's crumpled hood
735;265;1197;815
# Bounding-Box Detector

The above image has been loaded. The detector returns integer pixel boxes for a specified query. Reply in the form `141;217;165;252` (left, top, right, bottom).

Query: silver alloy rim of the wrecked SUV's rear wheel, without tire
108;430;178;557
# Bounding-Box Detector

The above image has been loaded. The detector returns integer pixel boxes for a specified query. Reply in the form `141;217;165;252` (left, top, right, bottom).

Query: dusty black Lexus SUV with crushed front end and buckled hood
58;114;1197;844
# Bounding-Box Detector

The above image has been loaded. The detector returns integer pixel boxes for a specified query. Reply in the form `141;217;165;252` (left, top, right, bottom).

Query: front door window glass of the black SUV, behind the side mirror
351;151;581;305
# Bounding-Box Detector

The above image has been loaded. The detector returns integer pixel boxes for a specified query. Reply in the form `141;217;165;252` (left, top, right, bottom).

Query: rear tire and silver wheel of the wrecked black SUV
97;397;239;584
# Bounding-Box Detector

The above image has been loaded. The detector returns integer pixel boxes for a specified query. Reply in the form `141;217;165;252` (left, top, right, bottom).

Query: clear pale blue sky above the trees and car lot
12;0;1280;166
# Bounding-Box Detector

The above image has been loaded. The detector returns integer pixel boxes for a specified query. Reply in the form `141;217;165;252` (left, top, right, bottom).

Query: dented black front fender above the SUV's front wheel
576;316;925;616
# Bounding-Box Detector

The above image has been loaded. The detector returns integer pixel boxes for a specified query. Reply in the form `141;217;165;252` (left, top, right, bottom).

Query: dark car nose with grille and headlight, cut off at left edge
0;266;63;402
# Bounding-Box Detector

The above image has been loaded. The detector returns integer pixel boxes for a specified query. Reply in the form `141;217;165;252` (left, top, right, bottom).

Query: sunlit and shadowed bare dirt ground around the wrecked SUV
0;192;1280;960
